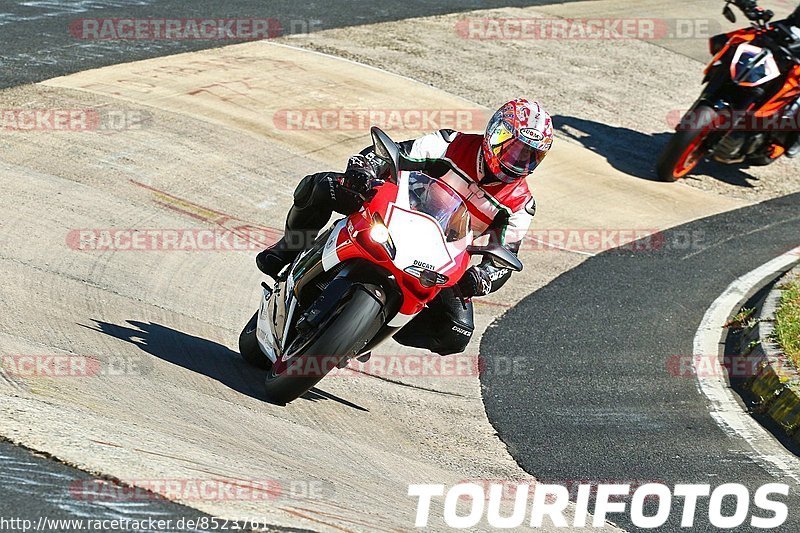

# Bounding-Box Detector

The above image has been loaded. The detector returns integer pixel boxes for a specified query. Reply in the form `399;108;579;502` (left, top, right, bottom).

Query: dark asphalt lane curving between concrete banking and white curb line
481;190;800;531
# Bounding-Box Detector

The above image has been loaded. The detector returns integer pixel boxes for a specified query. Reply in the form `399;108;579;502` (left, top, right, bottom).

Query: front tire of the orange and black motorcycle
656;105;717;182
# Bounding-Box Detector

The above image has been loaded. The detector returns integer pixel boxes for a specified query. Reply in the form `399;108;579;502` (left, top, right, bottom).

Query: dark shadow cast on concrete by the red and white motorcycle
79;319;368;412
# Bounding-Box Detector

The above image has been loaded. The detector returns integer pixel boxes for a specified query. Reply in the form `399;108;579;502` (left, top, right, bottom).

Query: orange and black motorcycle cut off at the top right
656;0;800;181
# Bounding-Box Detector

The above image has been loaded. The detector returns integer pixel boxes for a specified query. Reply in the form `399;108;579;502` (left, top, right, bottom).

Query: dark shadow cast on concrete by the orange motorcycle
553;115;758;188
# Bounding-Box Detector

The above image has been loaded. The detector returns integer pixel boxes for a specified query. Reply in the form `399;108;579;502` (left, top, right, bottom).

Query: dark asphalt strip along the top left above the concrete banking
0;0;576;88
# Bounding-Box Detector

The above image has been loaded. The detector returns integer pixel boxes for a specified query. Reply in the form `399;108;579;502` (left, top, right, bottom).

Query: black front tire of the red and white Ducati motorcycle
264;290;381;404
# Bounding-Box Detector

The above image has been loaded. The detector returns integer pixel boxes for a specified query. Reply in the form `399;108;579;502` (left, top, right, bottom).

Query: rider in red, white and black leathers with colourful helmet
256;98;553;355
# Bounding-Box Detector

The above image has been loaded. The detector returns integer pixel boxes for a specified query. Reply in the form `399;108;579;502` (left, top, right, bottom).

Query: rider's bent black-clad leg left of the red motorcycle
256;172;358;278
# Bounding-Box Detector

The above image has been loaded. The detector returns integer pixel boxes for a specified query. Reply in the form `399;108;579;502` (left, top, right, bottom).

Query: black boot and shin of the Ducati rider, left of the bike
256;200;331;279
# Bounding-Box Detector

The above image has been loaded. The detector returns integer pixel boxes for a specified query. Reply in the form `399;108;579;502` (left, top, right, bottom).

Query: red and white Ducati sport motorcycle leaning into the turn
239;128;522;404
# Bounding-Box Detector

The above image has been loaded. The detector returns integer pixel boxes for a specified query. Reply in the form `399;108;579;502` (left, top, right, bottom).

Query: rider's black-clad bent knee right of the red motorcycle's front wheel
394;289;475;355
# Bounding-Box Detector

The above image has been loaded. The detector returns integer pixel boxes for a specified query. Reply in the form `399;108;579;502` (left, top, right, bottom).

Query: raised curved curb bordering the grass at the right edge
747;266;800;444
